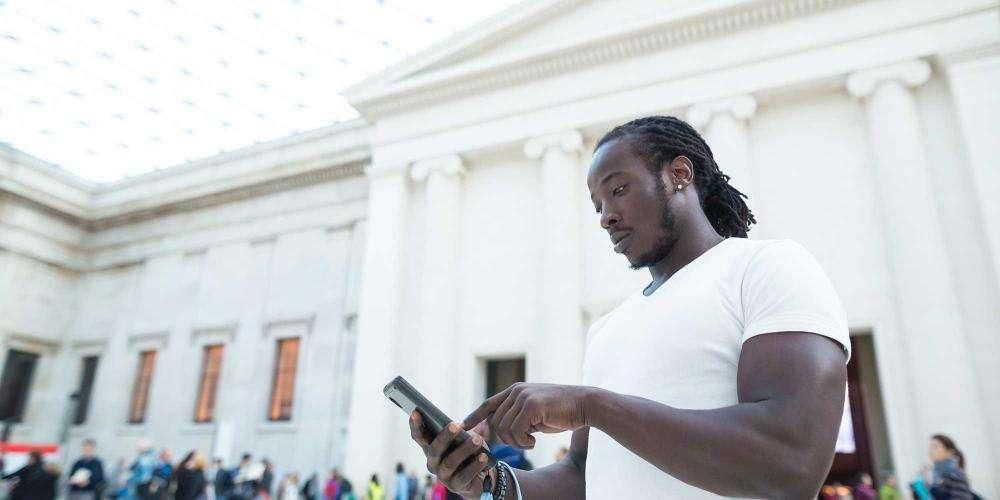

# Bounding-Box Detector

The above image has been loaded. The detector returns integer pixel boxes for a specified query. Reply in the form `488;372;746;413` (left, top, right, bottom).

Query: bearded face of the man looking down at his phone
587;140;678;269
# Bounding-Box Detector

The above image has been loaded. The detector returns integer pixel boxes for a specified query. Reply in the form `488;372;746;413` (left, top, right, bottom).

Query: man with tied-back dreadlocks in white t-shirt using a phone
410;116;850;500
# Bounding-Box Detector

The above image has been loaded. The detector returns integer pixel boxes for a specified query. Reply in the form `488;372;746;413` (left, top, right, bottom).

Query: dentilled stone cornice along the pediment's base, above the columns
351;0;864;118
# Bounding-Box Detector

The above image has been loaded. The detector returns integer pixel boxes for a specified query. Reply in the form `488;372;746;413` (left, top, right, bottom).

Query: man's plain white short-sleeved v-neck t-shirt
583;238;851;500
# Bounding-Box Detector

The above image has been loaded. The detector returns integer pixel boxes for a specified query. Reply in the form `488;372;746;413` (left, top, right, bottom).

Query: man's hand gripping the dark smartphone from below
410;410;488;498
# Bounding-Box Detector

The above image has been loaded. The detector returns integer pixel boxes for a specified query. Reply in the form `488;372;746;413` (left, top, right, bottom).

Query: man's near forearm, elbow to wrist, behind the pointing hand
586;389;832;498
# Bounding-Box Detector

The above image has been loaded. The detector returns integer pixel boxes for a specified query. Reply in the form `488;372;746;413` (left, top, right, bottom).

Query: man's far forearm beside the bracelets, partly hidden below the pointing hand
505;427;590;500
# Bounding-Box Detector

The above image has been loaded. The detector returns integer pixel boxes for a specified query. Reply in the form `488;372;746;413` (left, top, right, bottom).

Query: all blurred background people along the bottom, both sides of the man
3;434;980;500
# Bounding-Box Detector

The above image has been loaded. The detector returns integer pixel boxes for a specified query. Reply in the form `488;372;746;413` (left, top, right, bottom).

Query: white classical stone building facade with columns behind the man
0;0;1000;498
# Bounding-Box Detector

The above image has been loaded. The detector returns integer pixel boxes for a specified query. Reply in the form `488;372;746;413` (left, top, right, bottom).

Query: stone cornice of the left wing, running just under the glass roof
0;121;371;231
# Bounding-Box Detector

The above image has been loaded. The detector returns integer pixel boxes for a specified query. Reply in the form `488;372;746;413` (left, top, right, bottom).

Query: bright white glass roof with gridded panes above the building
0;0;514;182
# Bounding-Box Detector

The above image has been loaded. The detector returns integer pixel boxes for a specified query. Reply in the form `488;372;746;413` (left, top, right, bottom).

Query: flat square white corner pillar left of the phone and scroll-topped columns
344;165;409;485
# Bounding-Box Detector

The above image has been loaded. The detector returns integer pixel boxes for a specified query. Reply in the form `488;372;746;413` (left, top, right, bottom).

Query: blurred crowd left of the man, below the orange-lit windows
0;439;484;500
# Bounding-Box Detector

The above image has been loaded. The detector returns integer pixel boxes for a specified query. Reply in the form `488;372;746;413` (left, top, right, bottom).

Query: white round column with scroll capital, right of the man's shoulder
847;60;994;492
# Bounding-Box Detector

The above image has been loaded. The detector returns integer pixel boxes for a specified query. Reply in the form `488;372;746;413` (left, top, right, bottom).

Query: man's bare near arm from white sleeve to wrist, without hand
584;332;847;498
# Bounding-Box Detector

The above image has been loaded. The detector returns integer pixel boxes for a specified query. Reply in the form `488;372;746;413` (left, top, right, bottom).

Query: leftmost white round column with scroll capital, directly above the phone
410;155;470;420
